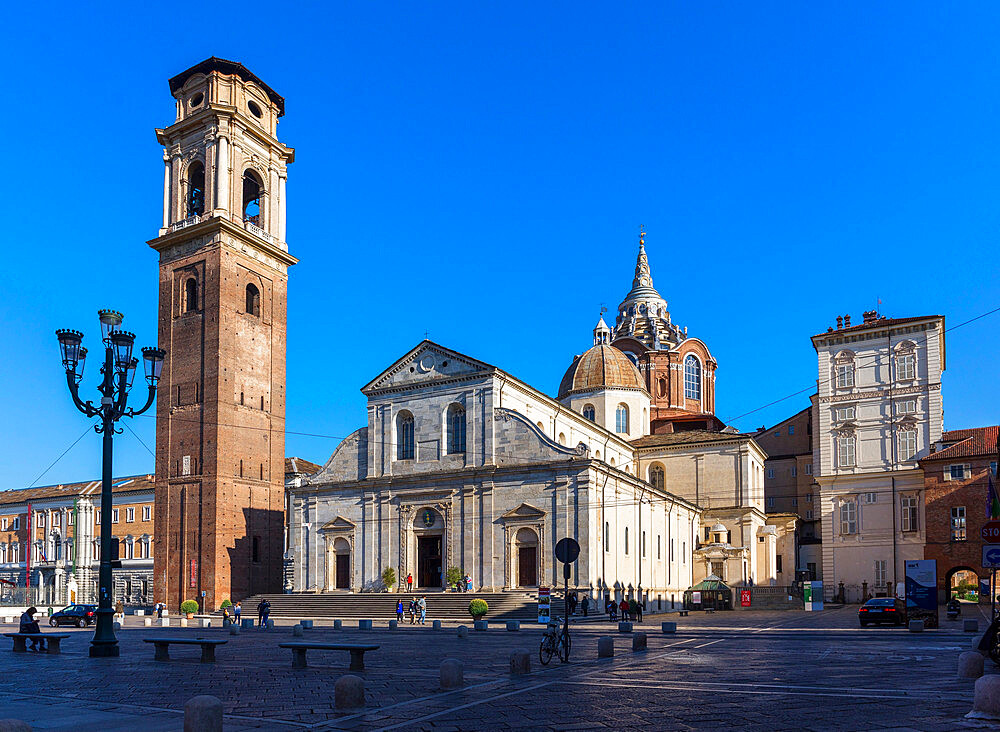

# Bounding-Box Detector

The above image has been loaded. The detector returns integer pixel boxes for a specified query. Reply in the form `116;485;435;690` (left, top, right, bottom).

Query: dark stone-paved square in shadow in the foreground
0;606;1000;732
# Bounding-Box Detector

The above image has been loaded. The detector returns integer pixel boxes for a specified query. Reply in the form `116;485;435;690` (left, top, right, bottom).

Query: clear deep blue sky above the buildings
0;2;1000;488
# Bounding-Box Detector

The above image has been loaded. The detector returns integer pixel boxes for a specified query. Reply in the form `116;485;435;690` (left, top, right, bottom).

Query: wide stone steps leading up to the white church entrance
230;592;565;622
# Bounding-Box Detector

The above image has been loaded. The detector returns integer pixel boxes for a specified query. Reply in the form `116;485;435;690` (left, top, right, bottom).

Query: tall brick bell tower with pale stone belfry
149;58;297;612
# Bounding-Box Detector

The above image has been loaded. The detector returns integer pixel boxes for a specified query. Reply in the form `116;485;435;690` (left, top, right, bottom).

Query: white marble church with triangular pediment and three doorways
289;341;700;606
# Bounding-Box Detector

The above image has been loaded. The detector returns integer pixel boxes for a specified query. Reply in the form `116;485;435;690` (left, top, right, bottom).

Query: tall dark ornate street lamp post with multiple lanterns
56;310;166;657
